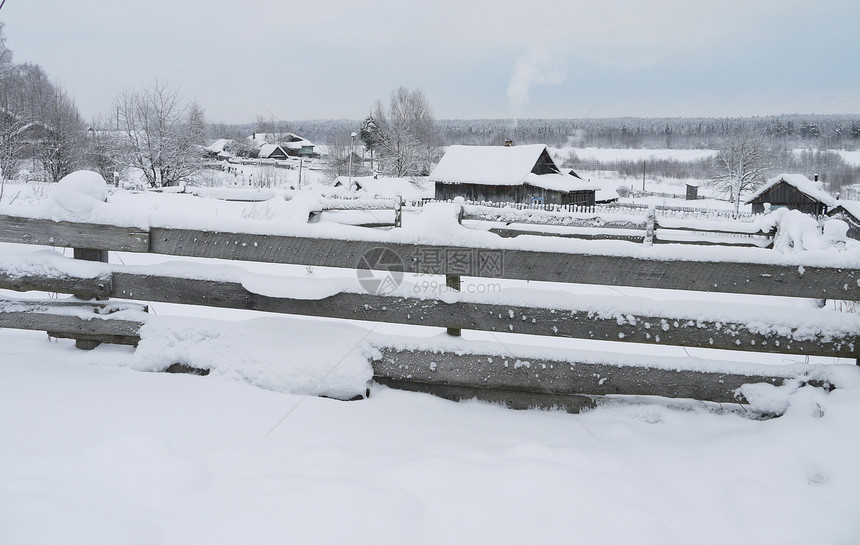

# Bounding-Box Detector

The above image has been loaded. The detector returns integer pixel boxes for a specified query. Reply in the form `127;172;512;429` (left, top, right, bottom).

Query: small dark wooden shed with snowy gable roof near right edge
745;174;836;216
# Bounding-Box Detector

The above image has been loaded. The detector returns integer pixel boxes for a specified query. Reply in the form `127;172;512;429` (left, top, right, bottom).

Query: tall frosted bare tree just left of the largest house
373;87;440;176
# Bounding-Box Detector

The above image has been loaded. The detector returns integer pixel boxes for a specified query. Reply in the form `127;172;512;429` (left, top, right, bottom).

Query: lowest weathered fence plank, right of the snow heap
373;347;812;403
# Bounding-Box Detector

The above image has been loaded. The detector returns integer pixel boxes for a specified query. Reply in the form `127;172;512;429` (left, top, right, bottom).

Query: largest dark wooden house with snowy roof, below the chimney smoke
429;144;596;206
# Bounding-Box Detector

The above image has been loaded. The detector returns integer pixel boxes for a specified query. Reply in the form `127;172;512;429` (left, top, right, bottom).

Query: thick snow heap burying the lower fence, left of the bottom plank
132;316;374;399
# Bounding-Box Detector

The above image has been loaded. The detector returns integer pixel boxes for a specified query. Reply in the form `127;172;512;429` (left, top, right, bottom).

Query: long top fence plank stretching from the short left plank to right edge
151;228;860;301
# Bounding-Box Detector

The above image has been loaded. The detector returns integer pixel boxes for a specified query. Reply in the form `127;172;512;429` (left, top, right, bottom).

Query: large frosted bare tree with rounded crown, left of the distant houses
114;80;205;187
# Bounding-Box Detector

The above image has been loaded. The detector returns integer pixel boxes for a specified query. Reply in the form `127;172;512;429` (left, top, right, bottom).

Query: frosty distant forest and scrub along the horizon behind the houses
209;115;860;197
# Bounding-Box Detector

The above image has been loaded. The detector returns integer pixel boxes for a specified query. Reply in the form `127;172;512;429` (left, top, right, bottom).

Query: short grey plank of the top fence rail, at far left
0;215;149;252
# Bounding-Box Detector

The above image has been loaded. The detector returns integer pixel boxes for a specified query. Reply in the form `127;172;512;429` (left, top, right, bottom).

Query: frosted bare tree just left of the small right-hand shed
712;129;774;213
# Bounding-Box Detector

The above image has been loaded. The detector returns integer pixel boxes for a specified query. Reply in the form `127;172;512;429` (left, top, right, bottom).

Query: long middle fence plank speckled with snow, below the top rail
0;272;832;358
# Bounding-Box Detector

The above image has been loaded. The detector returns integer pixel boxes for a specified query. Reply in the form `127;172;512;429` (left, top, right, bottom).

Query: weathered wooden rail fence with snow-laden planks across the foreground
0;212;860;410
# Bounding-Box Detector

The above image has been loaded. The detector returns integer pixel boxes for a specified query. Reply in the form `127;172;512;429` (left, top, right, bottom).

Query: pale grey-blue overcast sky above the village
0;0;860;123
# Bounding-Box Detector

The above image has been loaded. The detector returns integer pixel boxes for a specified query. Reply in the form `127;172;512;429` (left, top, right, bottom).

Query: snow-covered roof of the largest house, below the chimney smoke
430;144;593;191
